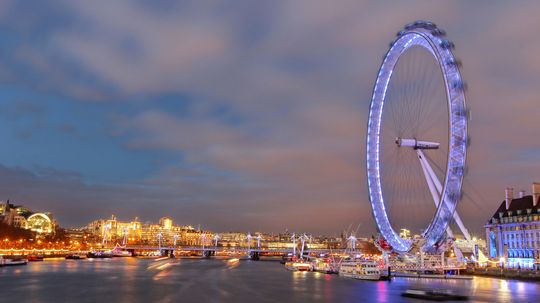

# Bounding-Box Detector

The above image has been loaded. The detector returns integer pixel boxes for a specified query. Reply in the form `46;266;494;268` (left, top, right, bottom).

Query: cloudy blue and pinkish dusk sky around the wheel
0;0;540;235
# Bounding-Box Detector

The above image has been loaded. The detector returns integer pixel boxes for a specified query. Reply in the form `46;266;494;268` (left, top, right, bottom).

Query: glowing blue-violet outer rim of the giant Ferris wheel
366;23;467;252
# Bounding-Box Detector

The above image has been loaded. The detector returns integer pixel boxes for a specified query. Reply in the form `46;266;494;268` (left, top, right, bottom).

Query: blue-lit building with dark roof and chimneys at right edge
485;183;540;269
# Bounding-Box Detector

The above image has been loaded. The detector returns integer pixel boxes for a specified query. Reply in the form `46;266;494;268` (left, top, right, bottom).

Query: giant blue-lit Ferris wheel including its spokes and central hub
367;21;470;253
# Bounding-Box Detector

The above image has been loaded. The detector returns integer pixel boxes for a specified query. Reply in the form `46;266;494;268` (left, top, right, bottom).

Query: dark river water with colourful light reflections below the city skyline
0;258;540;303
